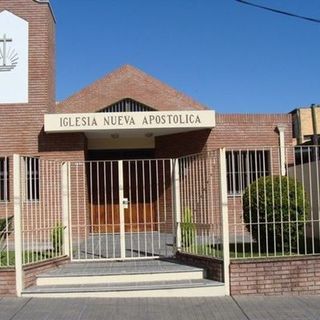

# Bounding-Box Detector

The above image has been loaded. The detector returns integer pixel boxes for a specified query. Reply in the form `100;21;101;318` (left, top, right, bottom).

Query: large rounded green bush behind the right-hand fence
243;176;310;252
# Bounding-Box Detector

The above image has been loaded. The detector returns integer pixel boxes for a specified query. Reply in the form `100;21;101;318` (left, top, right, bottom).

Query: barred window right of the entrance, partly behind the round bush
226;150;270;194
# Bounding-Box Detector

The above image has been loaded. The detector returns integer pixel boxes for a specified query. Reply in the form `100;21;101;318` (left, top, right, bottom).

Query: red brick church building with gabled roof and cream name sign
0;0;310;296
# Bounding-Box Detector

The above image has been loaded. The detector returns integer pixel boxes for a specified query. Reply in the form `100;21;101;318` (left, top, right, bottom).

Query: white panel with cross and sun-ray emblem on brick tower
0;10;29;104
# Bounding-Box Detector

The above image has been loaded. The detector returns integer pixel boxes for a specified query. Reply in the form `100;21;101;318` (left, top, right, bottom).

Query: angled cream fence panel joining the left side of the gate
19;156;66;265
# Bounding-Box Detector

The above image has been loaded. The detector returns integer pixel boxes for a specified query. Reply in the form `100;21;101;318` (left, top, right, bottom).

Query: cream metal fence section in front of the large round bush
226;146;320;259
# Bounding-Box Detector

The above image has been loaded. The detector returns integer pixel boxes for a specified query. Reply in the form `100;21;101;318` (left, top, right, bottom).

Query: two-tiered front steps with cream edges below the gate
22;260;225;298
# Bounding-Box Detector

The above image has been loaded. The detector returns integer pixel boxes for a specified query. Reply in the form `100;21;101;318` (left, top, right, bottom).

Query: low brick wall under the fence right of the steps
230;256;320;296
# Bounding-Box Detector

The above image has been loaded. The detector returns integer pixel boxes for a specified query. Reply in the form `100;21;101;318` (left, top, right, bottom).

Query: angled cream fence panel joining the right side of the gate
179;150;223;258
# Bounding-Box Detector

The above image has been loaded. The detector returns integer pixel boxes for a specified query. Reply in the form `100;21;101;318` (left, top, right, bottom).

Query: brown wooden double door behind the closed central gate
87;154;157;233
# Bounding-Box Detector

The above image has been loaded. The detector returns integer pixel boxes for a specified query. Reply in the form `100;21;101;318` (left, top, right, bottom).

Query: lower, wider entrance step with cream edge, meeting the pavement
22;279;225;298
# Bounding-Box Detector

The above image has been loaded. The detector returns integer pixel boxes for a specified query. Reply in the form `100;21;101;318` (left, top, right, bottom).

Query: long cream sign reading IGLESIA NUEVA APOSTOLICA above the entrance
44;110;215;132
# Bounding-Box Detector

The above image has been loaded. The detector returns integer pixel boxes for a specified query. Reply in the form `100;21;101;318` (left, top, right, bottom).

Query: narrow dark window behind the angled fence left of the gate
25;158;39;201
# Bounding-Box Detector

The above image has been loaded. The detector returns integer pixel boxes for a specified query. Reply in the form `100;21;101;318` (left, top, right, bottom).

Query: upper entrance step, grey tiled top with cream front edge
37;261;205;286
